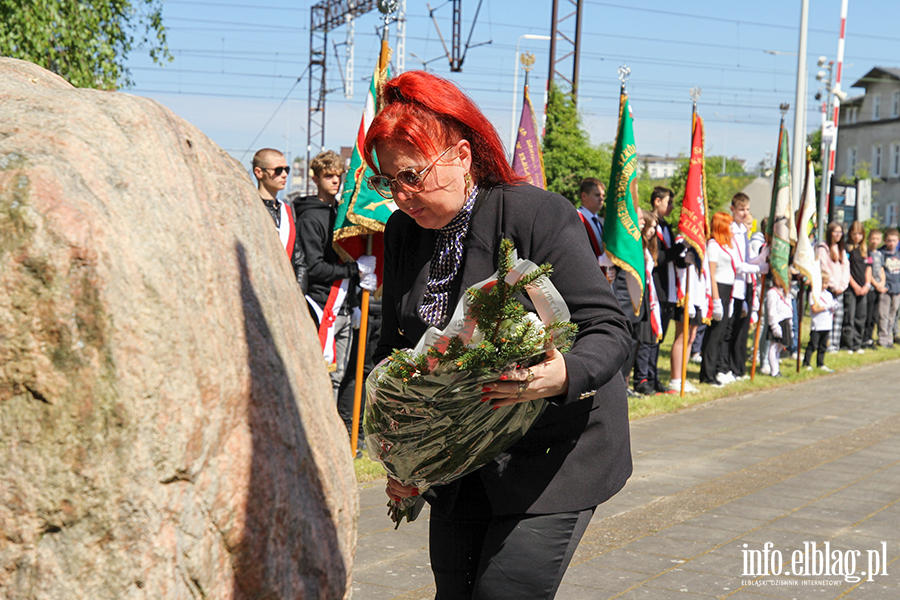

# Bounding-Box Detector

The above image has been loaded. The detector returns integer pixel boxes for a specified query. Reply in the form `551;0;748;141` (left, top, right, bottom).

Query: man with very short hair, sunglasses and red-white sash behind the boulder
252;148;308;295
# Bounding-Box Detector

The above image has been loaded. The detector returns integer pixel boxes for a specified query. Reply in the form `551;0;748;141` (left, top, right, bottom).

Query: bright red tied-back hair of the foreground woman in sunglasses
363;71;522;186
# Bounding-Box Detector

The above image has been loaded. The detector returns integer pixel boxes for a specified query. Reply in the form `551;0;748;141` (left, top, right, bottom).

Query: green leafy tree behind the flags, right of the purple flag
541;83;612;205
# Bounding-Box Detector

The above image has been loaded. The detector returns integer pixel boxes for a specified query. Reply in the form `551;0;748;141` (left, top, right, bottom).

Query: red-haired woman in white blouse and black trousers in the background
700;212;740;386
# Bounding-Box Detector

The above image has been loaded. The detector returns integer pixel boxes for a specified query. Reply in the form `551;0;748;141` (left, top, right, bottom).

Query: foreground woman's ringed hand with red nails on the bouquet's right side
481;348;569;409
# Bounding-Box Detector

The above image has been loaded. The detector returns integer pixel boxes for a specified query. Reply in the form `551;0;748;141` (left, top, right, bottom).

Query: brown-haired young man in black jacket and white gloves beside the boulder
294;150;378;400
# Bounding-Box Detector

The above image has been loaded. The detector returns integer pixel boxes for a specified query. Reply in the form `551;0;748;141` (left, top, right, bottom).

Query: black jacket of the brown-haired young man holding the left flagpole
288;194;359;307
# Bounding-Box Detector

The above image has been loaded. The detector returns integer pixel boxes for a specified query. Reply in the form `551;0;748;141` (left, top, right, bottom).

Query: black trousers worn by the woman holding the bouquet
429;472;594;600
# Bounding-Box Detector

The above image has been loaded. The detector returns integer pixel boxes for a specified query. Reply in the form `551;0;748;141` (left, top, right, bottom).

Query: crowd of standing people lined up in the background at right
579;178;900;396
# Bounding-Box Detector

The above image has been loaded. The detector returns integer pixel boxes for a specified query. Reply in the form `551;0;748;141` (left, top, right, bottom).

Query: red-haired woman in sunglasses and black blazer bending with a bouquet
365;71;631;600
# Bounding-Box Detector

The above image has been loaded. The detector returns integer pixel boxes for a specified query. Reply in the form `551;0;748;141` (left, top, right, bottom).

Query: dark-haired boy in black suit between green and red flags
634;186;685;396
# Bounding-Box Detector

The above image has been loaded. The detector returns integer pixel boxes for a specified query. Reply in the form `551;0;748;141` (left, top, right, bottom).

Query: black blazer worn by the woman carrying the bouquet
374;184;632;514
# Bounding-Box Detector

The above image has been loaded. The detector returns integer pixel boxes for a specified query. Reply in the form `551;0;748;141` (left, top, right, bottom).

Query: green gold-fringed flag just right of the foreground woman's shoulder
603;93;646;315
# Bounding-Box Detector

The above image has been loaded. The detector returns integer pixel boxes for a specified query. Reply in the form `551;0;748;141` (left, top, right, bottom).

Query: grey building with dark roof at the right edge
834;67;900;227
